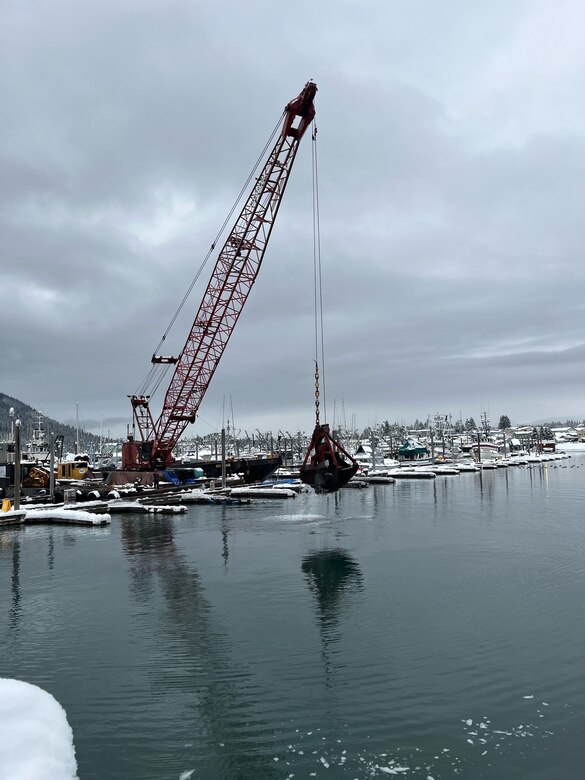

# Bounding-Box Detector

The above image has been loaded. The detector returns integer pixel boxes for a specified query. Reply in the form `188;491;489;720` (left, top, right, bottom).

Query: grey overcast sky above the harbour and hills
0;0;585;435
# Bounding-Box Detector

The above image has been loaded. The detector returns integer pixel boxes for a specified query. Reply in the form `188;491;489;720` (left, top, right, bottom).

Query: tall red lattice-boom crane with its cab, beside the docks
122;81;317;469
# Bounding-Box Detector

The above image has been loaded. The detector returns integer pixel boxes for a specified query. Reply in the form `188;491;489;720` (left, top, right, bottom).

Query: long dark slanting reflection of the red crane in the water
121;515;281;780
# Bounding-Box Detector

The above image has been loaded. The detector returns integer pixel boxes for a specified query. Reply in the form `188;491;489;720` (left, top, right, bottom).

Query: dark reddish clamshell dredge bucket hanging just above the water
300;424;358;493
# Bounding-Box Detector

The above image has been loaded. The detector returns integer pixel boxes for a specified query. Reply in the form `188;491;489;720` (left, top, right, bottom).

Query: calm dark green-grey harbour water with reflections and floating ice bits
0;458;585;780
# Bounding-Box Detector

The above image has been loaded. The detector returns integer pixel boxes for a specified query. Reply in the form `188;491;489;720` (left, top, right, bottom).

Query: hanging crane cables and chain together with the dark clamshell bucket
300;125;358;493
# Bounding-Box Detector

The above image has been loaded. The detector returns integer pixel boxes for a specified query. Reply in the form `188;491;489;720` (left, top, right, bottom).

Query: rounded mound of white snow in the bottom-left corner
0;677;77;780
